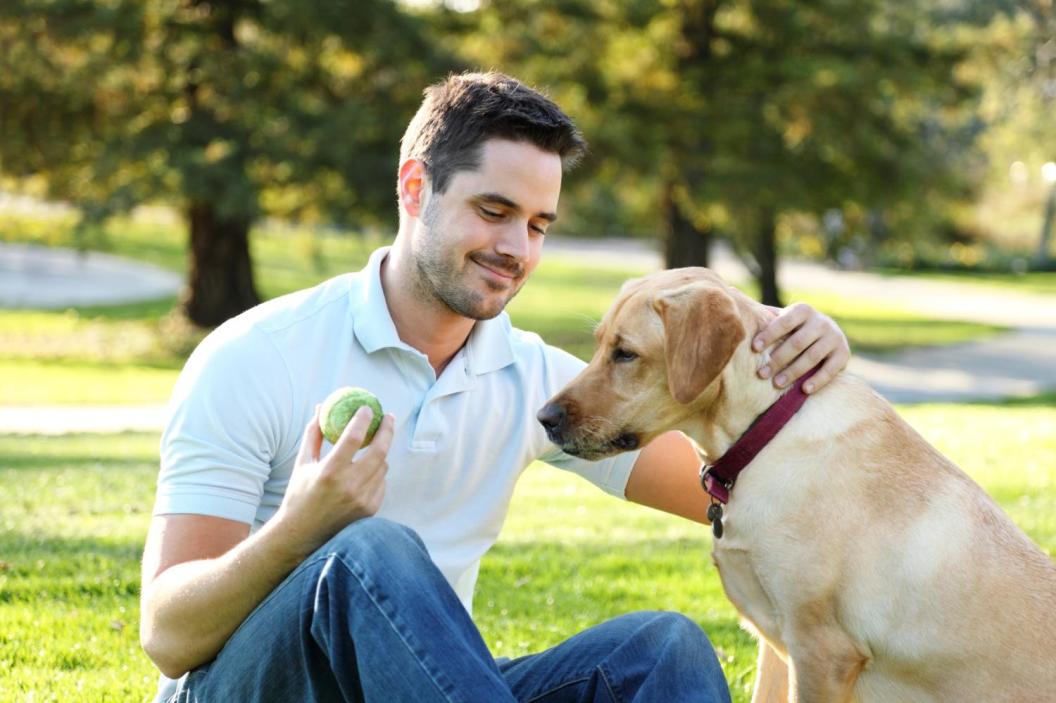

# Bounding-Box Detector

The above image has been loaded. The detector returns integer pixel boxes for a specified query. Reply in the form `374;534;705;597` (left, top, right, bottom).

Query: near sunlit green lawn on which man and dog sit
0;394;1056;703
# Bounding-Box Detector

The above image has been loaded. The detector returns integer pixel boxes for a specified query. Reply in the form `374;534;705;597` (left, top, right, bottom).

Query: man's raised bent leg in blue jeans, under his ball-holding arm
176;518;514;703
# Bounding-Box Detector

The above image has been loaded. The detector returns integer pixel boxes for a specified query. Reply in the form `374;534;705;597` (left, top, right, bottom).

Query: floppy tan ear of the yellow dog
653;283;748;404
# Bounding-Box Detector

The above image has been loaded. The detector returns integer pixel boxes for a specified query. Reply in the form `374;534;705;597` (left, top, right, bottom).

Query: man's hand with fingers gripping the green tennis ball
275;405;394;555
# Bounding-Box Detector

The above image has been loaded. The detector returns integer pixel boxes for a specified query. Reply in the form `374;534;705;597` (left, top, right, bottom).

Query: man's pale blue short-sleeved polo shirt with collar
154;243;638;610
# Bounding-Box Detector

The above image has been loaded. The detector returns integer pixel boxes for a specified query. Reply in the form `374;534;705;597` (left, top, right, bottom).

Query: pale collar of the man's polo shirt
351;247;514;376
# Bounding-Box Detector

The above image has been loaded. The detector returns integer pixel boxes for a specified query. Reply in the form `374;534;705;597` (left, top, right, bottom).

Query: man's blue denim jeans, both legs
171;517;730;703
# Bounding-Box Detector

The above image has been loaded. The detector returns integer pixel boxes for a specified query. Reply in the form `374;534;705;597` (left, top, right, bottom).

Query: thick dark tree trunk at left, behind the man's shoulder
181;203;260;327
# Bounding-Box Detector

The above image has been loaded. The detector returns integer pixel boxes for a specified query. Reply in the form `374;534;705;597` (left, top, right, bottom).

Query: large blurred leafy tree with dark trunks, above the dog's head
449;0;973;304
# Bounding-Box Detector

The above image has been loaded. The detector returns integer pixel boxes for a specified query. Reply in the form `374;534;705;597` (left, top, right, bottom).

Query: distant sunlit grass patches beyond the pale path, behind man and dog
0;217;1002;405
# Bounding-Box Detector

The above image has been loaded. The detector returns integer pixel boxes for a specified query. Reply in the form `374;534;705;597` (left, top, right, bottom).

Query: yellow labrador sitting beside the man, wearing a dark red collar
547;268;1056;703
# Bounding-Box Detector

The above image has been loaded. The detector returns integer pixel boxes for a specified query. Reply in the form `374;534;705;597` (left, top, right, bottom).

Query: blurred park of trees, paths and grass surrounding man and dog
0;0;1056;703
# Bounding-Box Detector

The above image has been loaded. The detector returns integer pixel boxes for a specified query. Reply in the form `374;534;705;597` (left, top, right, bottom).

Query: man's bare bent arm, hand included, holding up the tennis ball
139;409;393;678
